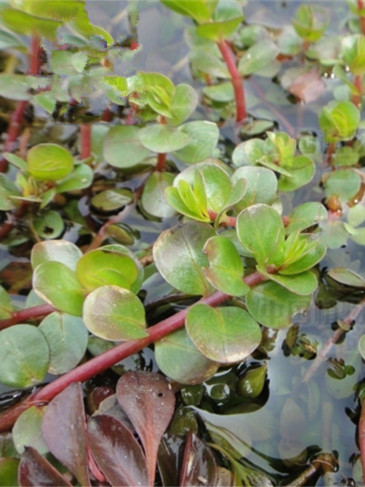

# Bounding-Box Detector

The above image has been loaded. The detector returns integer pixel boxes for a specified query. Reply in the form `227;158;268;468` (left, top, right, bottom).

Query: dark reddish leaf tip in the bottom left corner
18;446;72;487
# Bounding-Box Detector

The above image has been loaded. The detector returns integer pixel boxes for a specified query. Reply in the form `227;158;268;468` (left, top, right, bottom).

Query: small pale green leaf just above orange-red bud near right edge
324;169;361;203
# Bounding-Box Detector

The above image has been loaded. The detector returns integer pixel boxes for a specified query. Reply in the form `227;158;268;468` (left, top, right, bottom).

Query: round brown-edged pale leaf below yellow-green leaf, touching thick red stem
83;286;147;341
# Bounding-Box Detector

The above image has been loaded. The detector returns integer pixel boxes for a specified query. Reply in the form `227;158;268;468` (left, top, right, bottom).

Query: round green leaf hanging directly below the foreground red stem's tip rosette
246;282;312;329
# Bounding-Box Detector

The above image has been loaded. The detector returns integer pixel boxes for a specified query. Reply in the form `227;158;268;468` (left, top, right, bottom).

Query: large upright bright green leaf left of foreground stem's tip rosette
236;204;285;265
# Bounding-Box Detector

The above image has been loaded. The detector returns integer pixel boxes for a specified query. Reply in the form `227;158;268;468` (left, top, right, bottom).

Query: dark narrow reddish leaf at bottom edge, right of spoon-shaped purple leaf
180;431;217;487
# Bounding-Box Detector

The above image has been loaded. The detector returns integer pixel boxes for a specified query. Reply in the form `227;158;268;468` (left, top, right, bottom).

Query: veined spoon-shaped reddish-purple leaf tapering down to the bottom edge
117;372;175;486
